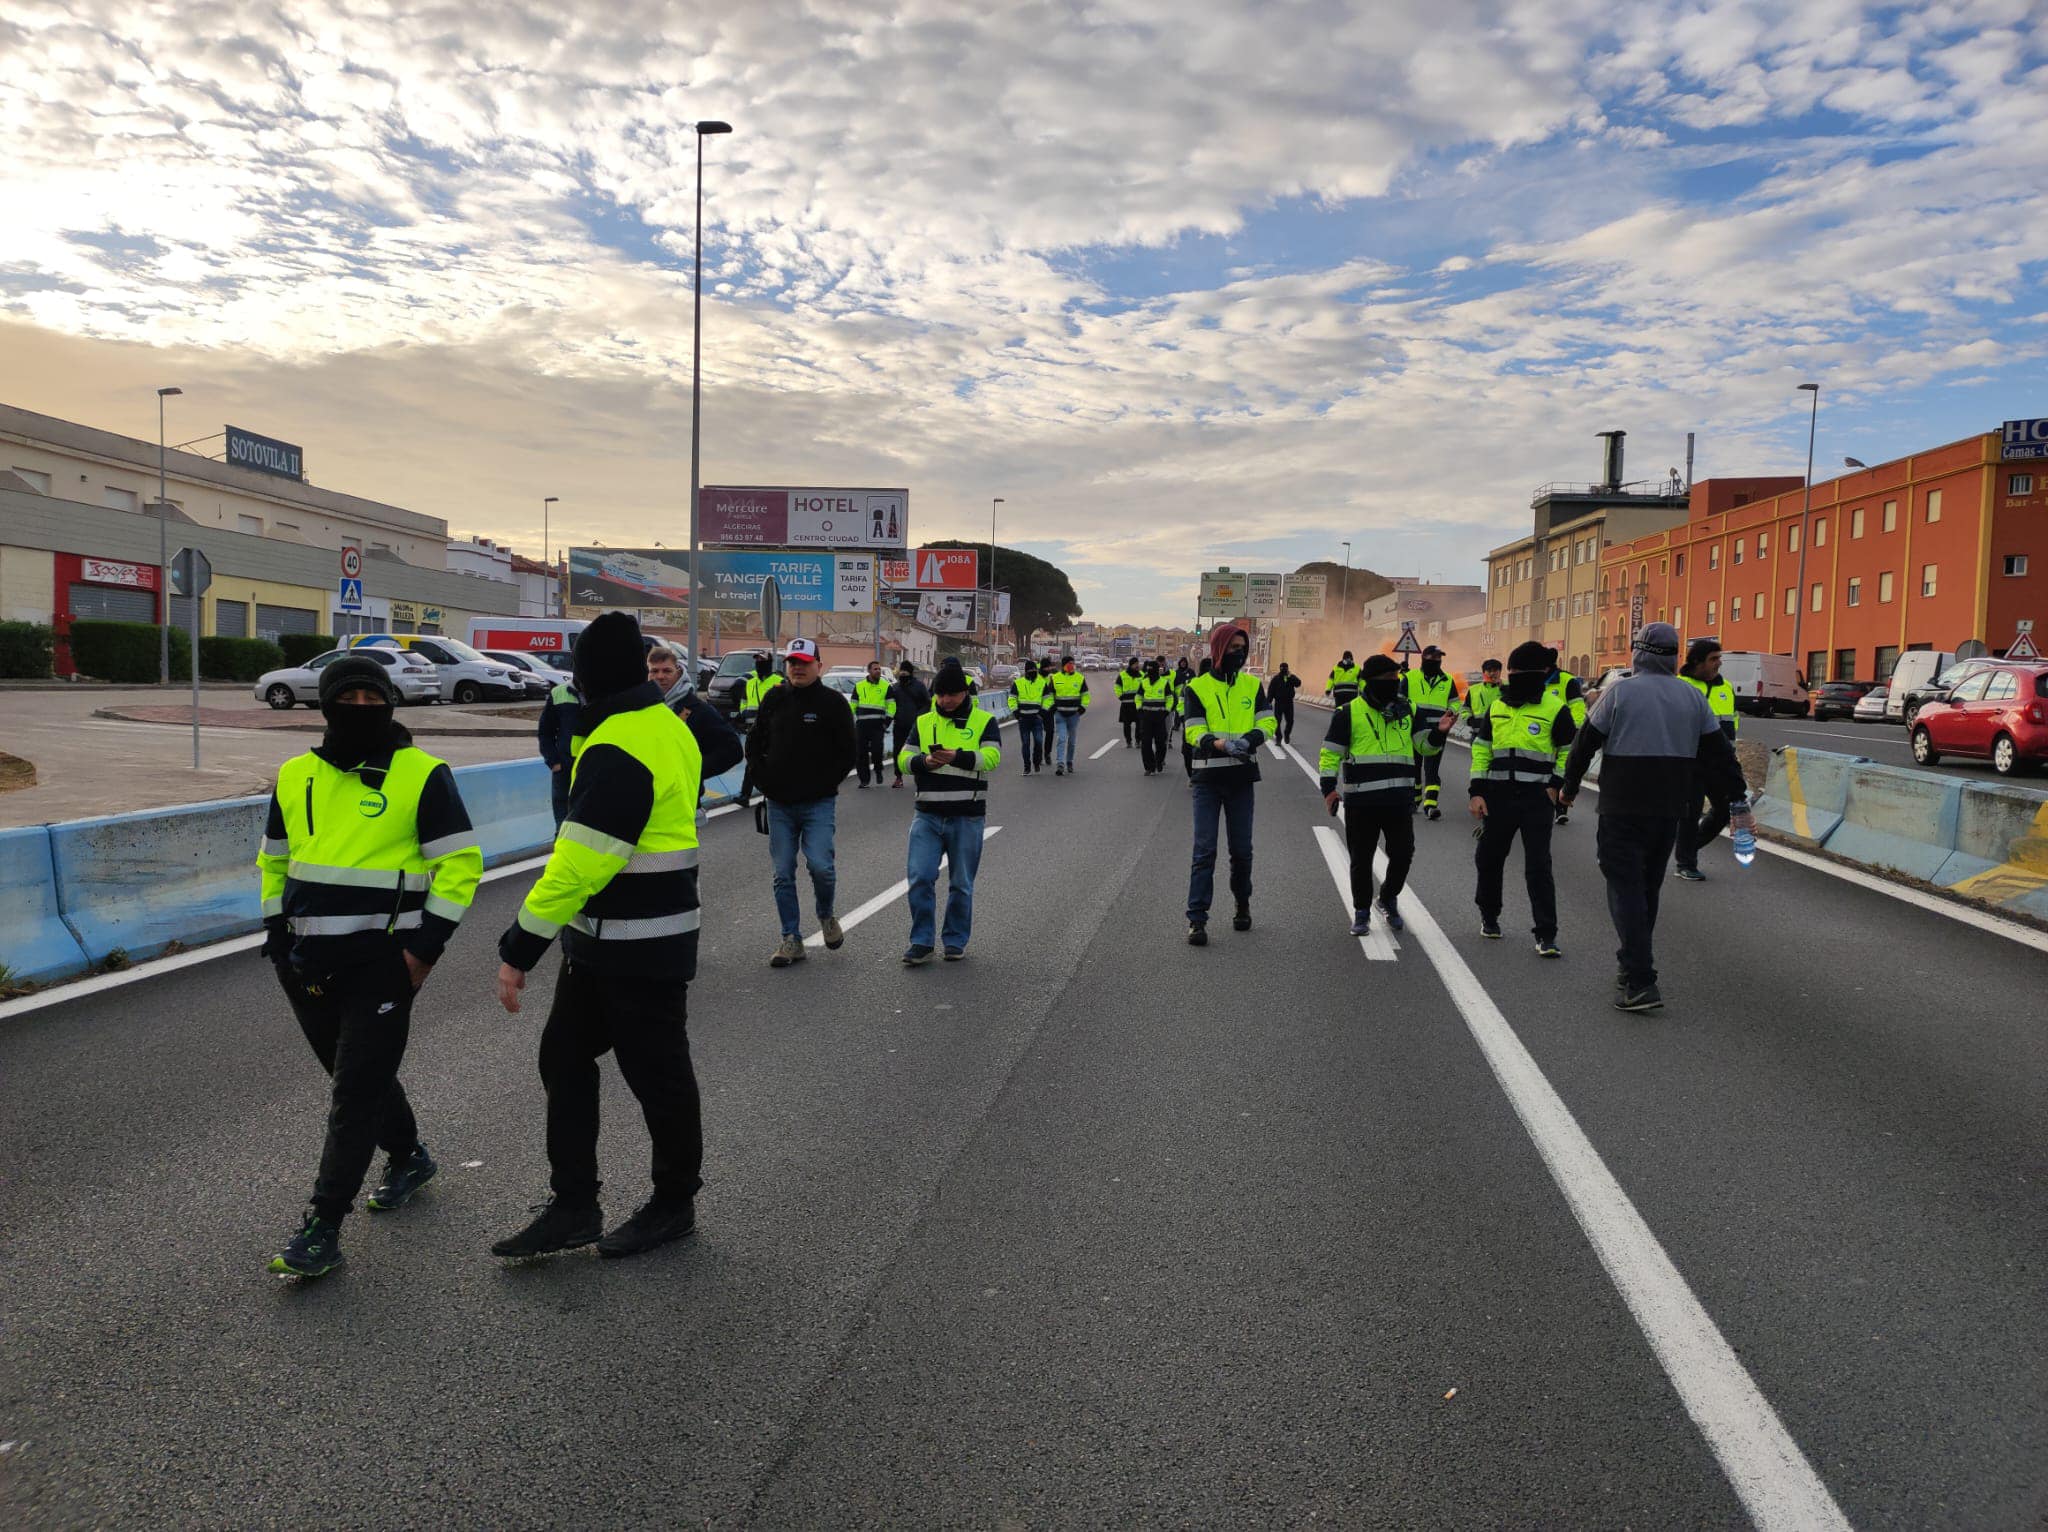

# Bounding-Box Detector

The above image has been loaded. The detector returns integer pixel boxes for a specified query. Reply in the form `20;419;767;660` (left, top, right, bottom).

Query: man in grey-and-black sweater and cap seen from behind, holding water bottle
1561;623;1751;1012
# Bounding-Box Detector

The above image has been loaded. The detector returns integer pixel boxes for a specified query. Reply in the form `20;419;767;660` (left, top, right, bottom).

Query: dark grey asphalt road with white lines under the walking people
0;688;2048;1528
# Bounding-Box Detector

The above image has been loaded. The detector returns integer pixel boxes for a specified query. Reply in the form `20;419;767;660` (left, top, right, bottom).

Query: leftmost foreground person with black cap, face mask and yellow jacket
256;655;483;1278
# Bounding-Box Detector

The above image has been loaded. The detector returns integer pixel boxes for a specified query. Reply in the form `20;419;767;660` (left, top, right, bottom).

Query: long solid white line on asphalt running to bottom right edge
1401;880;1849;1532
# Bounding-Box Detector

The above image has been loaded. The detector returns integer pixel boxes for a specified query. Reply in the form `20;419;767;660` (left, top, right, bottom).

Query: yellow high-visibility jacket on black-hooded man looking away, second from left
518;703;705;969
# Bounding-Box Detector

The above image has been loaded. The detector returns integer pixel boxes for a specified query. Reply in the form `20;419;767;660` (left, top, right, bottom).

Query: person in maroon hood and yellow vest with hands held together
1184;623;1274;946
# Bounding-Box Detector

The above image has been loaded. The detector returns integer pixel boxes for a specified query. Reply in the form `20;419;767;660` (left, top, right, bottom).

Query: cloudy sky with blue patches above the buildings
0;0;2048;621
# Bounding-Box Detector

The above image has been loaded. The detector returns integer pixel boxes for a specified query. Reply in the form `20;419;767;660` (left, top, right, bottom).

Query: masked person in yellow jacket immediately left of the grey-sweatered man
1473;643;1577;959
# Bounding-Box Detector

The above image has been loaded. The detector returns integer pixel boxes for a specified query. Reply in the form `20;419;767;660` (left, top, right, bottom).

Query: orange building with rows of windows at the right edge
1595;430;2048;682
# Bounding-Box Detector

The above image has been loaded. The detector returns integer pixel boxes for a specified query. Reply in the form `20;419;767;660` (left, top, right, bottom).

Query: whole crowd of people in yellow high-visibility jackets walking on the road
256;612;1749;1278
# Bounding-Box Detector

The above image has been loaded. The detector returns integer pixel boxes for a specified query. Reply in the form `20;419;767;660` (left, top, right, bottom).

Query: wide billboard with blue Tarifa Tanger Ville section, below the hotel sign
569;547;874;612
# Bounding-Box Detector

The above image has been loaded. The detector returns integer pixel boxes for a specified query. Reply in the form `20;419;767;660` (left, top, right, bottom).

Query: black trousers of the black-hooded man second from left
541;961;705;1206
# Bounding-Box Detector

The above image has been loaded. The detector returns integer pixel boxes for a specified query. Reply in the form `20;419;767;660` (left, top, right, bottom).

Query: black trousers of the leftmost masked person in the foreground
276;938;420;1223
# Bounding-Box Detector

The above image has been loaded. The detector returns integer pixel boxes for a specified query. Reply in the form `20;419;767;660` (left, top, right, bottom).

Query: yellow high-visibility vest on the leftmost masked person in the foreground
256;746;483;936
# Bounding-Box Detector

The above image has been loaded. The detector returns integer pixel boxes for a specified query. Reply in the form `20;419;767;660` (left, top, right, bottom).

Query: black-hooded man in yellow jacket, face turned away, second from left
492;612;705;1258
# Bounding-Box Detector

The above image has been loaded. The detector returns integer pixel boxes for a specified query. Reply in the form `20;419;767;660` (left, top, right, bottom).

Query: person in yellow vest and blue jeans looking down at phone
901;659;1004;969
